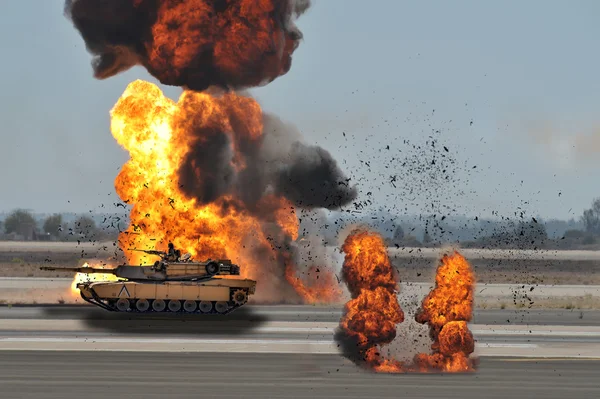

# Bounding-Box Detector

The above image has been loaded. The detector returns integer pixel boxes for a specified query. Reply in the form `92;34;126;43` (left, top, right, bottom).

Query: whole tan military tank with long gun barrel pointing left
41;250;256;314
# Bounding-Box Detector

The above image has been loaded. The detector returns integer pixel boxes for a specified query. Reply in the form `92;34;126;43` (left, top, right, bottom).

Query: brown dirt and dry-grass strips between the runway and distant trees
0;243;600;309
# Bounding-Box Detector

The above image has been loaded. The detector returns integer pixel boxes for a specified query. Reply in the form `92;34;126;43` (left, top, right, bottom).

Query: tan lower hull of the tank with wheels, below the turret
77;278;256;314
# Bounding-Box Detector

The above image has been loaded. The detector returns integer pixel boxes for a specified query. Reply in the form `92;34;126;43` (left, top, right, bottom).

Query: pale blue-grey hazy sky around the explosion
0;0;600;219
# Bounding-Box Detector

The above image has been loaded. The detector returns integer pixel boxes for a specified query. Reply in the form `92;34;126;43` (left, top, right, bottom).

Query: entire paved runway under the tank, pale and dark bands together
0;306;600;399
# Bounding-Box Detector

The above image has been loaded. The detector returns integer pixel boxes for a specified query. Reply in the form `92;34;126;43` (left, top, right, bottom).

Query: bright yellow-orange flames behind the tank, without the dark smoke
111;80;336;303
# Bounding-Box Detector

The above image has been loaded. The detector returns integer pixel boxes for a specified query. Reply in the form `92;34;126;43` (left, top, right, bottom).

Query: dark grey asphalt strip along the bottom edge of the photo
0;351;600;399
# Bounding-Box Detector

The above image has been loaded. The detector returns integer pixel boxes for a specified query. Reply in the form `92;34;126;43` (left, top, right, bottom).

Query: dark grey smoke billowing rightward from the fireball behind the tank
176;103;357;213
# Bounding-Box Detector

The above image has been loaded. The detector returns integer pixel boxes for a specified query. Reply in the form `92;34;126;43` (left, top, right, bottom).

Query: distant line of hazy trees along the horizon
0;198;600;249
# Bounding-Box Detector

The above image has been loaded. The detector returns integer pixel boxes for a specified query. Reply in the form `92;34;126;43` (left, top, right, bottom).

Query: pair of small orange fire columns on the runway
336;229;475;373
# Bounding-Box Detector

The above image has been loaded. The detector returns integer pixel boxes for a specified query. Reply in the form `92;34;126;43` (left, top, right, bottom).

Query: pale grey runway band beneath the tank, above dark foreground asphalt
0;306;600;358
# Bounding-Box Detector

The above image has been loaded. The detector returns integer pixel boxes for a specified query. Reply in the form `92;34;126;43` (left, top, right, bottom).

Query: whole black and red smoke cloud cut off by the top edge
65;0;310;91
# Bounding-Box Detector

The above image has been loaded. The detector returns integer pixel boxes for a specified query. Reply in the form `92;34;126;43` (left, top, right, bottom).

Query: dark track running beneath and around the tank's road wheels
80;290;247;315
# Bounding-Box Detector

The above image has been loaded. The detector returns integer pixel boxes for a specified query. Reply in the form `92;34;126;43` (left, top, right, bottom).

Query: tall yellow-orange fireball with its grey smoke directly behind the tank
111;81;354;302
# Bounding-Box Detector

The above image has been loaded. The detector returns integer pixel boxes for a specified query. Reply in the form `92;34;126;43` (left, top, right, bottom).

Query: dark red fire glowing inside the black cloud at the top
144;0;297;90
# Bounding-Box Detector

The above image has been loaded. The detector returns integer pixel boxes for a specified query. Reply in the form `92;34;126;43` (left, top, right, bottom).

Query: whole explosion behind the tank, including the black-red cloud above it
65;0;356;303
